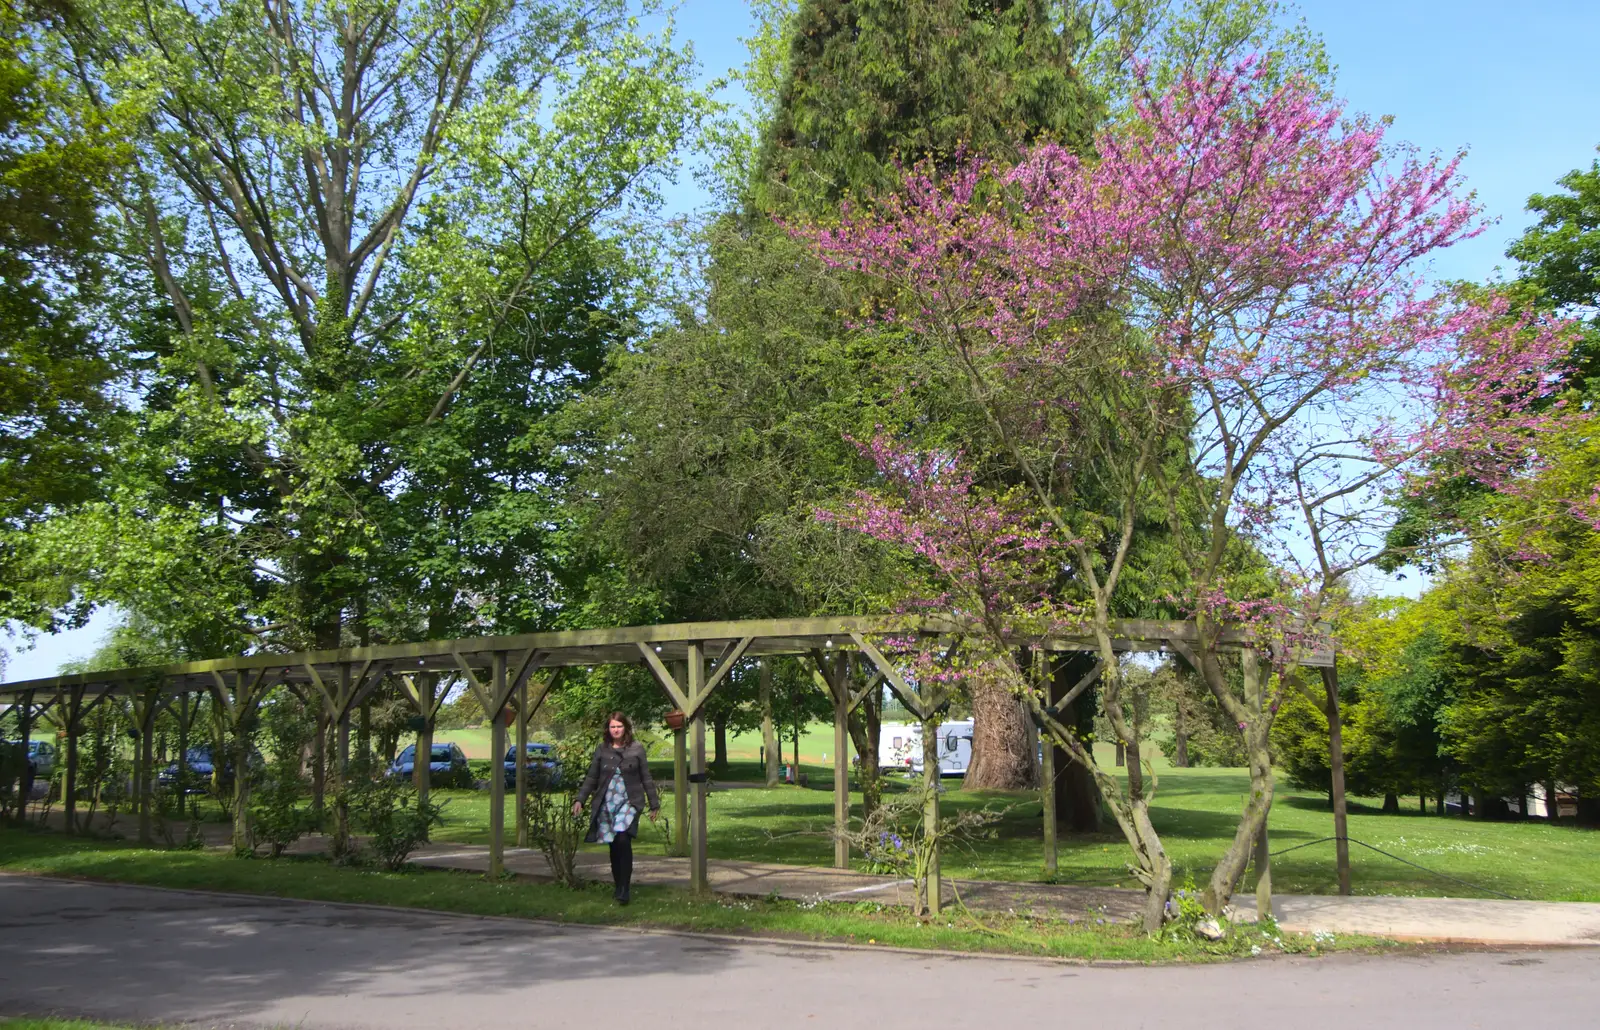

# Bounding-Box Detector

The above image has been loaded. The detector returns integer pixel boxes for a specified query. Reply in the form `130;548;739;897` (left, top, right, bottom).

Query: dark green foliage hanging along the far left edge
0;5;120;627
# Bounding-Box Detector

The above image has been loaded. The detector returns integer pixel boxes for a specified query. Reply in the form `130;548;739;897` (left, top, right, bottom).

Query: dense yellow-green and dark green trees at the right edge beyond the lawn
1352;152;1600;820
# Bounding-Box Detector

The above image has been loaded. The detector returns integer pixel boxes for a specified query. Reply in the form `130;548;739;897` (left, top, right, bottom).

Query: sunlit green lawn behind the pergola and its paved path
416;741;1600;902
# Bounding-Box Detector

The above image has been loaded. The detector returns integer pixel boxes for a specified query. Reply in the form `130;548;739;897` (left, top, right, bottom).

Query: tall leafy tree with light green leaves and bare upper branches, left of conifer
23;0;706;651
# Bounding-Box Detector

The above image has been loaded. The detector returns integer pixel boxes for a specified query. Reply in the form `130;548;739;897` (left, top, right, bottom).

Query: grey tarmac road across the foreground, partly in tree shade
0;875;1600;1030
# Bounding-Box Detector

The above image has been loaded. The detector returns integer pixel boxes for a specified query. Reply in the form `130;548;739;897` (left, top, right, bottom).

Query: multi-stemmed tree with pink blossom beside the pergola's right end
798;62;1579;929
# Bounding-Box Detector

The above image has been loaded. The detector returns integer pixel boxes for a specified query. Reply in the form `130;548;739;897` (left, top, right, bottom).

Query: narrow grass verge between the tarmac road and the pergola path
0;828;1397;966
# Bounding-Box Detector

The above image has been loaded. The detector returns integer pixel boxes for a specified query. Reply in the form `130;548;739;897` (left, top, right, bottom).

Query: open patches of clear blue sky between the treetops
0;0;1600;680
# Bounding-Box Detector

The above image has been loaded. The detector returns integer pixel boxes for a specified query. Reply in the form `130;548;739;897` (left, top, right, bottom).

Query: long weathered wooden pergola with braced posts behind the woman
0;616;1349;902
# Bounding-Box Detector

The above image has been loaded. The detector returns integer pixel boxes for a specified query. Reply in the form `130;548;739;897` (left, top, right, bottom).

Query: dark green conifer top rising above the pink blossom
750;0;1099;218
